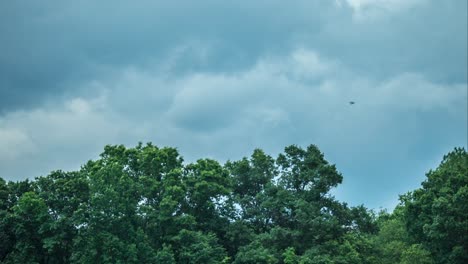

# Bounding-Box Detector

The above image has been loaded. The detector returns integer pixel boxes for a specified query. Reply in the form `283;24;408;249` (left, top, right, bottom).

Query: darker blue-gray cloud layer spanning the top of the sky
0;0;467;113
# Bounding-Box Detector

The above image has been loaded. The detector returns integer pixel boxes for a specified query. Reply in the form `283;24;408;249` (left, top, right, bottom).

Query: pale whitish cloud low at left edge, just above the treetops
0;94;129;179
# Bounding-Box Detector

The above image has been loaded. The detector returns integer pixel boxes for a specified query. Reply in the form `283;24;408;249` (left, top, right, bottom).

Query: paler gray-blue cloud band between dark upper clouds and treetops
0;48;467;207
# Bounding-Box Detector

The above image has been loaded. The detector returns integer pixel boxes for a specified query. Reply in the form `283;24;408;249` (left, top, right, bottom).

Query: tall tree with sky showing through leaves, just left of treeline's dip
272;145;350;254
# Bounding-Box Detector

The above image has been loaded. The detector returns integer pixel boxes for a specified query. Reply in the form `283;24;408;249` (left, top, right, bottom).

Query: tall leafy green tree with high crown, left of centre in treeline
71;146;156;263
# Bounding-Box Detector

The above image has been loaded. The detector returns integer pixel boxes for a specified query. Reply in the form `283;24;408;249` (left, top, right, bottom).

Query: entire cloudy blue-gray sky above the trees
0;0;467;208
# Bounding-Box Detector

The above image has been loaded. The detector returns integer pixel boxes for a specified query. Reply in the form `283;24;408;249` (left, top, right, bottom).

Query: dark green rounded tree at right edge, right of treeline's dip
401;148;468;263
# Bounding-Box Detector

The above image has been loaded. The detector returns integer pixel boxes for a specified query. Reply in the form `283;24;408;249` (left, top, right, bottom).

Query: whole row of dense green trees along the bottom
0;144;468;264
